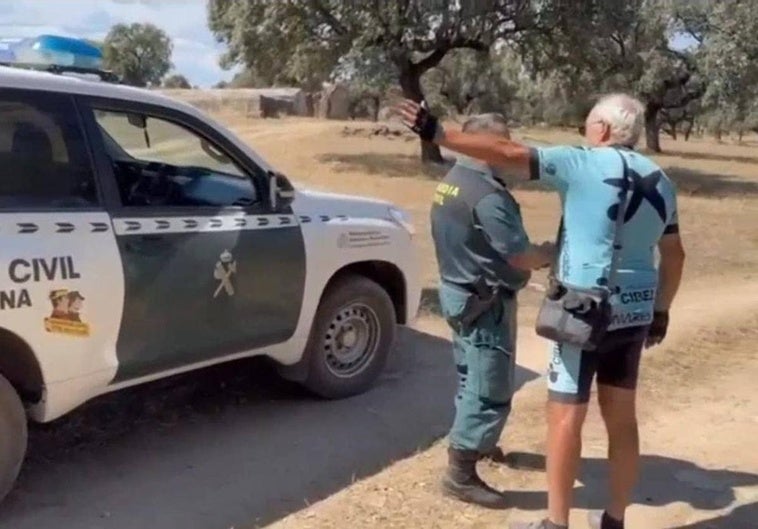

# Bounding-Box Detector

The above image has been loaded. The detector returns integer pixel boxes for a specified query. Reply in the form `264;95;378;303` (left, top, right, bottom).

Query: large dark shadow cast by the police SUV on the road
0;328;538;529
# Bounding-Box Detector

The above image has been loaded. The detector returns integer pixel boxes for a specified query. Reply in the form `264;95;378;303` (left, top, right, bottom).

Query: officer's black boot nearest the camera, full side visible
442;448;506;509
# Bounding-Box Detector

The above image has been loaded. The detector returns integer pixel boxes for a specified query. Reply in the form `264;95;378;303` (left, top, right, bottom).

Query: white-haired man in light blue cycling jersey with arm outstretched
397;94;684;529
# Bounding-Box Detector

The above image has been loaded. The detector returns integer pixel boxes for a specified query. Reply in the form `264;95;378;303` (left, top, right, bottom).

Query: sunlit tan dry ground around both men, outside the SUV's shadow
197;115;758;529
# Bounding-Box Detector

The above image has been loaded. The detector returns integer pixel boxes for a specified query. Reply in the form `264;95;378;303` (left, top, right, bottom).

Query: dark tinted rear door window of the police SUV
0;90;98;209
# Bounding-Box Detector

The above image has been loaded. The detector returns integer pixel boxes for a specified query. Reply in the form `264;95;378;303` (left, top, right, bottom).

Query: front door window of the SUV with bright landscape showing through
95;109;258;207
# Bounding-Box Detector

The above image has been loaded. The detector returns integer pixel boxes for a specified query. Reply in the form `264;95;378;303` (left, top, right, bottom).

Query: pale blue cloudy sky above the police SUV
0;0;234;87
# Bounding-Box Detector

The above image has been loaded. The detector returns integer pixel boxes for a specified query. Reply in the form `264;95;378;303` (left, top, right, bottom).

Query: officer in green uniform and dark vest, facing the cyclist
431;114;554;508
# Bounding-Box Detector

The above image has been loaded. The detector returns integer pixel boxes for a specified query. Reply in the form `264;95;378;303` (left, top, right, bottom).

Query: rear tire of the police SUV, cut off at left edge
0;375;28;501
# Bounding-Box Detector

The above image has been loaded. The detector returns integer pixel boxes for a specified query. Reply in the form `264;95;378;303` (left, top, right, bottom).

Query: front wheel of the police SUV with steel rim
304;275;397;399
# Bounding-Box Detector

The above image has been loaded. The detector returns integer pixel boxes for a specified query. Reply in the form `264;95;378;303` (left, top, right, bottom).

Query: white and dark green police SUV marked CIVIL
0;45;420;497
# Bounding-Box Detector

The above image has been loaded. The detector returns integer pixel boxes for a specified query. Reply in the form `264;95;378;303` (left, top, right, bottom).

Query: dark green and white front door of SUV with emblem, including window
82;99;305;381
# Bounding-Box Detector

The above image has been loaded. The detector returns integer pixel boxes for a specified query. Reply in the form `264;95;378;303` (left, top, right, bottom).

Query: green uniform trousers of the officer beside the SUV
440;282;516;453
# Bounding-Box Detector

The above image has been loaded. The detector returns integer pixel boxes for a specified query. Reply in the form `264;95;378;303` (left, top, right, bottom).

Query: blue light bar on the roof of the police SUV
8;35;103;70
